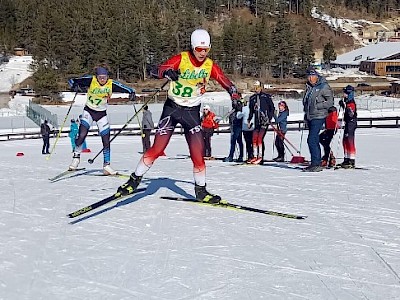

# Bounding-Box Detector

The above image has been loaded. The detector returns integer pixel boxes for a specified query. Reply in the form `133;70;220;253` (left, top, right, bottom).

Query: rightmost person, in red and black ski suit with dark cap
339;85;357;169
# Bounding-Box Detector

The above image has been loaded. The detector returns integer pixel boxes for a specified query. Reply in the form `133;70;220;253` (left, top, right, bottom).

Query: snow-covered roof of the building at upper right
331;42;400;66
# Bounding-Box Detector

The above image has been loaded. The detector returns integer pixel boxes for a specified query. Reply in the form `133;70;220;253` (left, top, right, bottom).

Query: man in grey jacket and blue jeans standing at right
303;66;334;172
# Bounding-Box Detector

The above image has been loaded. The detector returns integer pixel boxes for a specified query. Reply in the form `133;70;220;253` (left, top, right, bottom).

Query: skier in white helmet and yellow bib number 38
118;29;240;203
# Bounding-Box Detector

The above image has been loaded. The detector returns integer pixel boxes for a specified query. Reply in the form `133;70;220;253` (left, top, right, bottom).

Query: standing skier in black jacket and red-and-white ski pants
247;81;275;164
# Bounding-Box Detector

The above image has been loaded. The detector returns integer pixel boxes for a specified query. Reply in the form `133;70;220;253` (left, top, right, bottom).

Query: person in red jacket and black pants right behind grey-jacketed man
319;106;338;167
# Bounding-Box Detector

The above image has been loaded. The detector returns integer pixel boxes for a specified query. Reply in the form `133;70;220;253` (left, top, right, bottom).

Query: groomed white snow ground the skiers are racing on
0;129;400;300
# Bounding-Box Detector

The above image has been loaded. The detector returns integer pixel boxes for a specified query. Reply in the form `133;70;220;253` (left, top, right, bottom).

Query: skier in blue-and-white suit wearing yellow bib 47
68;67;135;175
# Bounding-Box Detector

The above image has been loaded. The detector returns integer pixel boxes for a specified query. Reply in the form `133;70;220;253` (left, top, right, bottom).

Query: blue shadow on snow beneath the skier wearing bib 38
69;177;194;224
